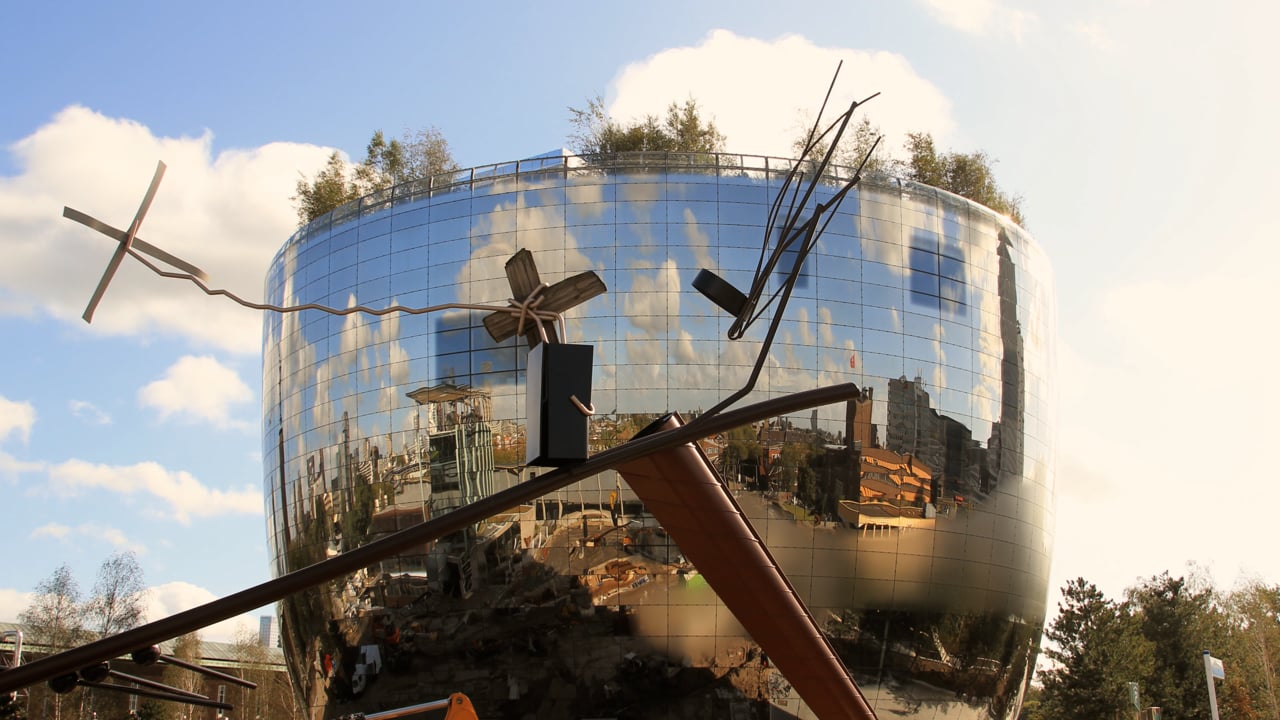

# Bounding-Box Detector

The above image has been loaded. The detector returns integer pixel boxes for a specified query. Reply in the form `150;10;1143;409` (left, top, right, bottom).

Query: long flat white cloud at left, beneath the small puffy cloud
49;460;262;525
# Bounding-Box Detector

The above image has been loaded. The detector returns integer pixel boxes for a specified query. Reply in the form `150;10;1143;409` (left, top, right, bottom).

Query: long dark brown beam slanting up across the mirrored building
0;383;859;692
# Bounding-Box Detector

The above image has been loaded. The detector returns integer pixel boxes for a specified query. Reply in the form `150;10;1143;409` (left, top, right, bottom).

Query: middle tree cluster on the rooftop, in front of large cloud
568;96;724;155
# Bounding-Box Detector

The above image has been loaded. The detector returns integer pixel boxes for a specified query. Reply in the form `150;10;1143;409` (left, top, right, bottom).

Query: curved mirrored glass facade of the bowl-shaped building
264;149;1053;717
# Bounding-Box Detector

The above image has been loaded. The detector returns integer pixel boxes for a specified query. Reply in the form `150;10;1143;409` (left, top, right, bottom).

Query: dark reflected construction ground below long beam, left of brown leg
299;502;788;717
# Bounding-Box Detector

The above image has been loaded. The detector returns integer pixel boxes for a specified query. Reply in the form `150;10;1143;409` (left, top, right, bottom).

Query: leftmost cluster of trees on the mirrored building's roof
293;127;458;224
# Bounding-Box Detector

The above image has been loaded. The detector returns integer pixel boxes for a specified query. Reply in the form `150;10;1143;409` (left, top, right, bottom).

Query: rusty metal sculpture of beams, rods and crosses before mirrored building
27;68;878;719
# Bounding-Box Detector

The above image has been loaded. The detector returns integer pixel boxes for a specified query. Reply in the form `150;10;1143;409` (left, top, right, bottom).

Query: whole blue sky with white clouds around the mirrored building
0;0;1280;637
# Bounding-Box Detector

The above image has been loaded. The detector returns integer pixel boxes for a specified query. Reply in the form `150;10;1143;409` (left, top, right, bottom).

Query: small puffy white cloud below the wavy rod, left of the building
138;355;256;430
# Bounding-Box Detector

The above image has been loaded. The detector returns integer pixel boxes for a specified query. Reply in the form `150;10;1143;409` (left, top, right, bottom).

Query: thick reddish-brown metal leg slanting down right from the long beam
616;414;876;719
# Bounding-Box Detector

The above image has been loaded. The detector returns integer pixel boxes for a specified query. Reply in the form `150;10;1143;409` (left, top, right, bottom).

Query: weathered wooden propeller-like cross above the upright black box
484;249;605;347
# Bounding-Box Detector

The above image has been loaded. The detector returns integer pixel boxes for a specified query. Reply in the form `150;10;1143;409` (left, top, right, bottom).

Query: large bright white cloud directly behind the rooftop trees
608;29;952;156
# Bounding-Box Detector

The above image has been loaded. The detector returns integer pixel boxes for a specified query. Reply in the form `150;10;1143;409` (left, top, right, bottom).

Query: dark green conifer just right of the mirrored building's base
1037;578;1155;720
